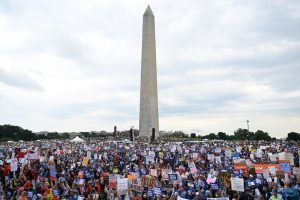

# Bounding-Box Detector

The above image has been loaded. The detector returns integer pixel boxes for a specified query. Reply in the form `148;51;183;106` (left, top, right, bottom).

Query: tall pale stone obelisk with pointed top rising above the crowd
139;6;159;139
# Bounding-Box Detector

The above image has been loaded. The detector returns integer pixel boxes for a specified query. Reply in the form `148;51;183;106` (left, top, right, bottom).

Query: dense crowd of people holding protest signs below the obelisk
0;139;300;200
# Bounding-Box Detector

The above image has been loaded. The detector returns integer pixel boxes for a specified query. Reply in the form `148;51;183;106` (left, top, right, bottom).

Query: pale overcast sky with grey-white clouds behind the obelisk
0;0;300;137
